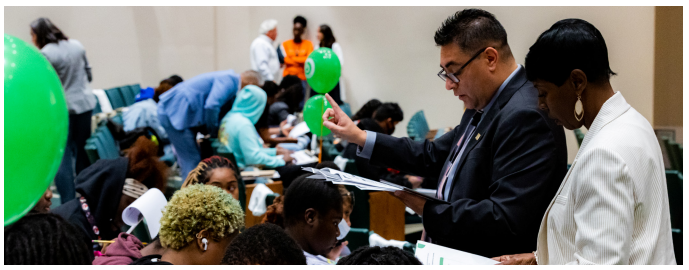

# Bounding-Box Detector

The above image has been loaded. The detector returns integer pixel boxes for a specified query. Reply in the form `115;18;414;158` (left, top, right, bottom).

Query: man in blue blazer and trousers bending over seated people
158;70;262;179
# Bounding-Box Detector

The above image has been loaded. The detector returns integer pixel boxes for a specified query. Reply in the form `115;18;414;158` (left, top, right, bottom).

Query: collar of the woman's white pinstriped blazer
574;91;632;160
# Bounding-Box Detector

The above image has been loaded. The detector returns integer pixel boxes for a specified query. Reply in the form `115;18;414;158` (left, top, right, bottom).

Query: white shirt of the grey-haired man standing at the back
251;35;280;81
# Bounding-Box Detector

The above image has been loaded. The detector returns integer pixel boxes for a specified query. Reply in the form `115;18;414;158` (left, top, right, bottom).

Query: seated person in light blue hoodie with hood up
218;85;292;168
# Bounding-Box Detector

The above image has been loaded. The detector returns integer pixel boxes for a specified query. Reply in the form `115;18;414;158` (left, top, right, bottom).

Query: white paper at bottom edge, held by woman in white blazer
415;241;498;265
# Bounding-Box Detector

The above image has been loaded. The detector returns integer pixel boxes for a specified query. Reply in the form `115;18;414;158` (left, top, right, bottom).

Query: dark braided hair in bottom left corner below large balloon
5;213;93;265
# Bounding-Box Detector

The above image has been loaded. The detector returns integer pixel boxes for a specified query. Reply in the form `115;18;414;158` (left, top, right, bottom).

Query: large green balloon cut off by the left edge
4;34;69;226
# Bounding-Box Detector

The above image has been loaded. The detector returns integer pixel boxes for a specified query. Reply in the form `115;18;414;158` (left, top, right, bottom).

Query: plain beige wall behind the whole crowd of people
5;7;655;162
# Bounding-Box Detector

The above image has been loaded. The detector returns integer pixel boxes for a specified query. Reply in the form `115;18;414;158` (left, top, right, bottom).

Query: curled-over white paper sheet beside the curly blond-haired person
122;188;167;238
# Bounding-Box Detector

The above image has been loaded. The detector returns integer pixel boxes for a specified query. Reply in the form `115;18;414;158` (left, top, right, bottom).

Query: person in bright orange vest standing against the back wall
280;16;313;108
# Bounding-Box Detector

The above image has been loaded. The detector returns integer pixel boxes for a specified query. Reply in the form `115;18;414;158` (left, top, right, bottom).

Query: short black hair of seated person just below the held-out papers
283;174;343;227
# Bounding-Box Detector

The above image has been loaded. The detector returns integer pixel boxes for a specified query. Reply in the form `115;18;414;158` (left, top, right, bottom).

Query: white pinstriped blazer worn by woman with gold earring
537;92;677;264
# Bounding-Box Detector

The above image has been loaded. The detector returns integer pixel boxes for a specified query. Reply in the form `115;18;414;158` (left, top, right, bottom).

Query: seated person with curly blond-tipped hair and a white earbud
131;185;244;265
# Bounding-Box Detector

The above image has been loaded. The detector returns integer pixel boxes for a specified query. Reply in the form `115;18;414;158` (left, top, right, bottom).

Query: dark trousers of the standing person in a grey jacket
55;110;93;203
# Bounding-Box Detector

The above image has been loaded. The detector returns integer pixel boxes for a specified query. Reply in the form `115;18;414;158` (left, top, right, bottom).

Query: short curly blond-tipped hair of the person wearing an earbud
160;185;244;250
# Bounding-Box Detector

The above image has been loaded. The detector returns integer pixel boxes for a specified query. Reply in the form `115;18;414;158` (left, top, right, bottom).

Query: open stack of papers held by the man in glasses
302;167;448;203
